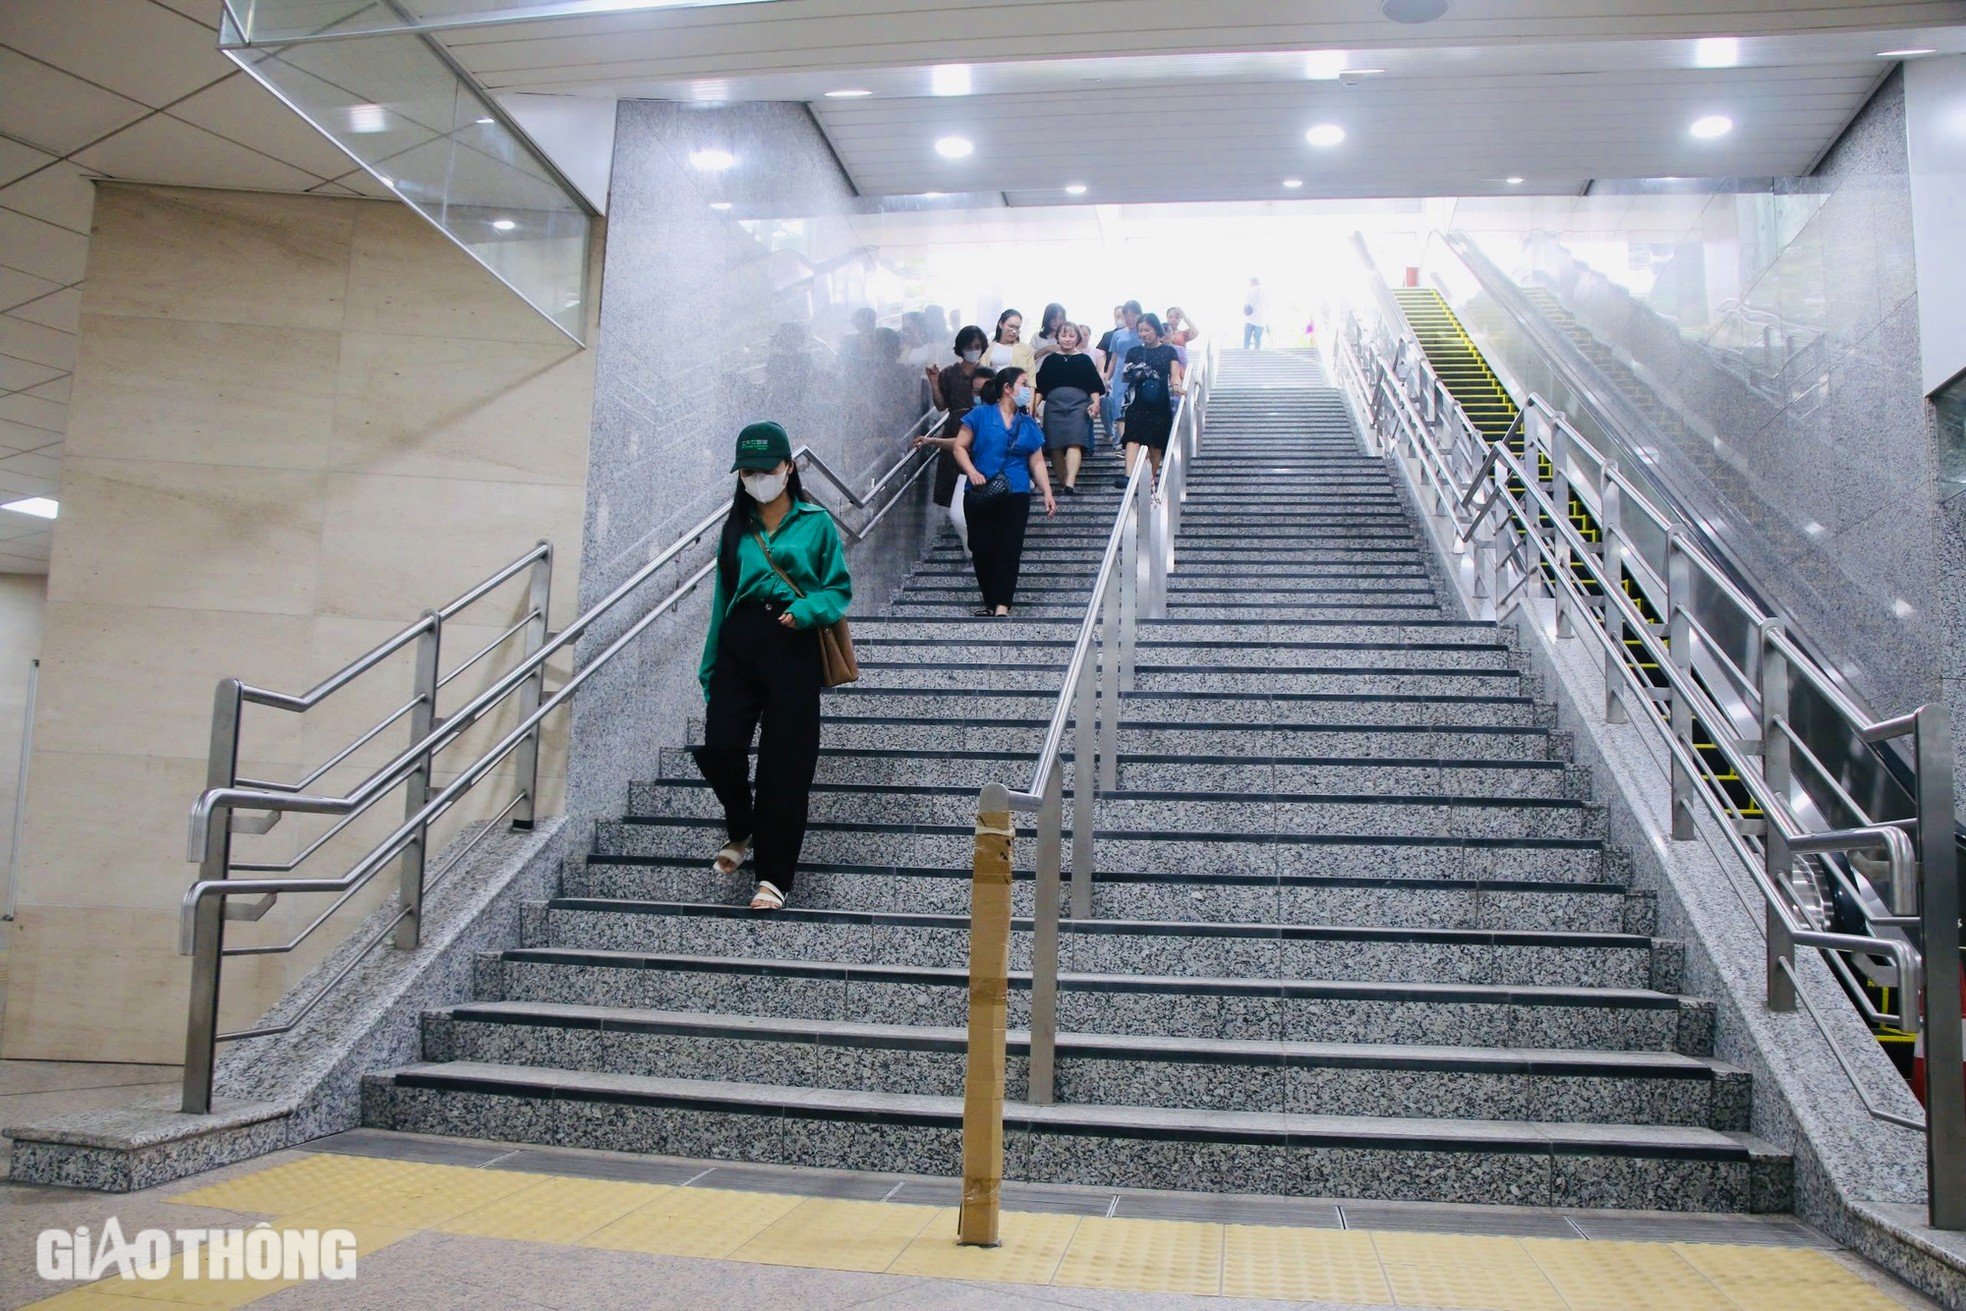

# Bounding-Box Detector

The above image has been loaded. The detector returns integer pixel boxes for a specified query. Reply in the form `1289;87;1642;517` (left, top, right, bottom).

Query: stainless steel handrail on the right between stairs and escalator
1339;297;1966;1228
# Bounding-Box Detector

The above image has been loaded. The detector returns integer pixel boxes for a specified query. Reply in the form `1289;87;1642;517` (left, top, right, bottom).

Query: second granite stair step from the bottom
434;1002;1748;1130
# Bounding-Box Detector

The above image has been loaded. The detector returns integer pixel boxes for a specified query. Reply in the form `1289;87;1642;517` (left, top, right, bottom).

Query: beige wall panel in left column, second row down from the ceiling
67;314;340;470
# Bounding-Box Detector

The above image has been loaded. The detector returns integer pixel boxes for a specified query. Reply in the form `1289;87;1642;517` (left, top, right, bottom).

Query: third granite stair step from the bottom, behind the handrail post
474;947;1712;1055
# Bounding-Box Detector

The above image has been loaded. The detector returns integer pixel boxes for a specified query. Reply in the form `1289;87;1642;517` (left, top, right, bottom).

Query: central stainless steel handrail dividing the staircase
963;342;1217;1230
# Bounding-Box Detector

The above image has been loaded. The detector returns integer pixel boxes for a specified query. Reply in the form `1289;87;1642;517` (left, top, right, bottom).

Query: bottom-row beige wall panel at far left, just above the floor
0;906;281;1065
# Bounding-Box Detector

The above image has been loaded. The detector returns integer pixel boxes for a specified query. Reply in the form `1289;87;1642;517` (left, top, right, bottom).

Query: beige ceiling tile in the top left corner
0;0;232;108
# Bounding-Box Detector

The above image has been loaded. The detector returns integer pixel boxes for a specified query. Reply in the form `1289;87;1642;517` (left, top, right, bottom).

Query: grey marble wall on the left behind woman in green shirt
570;100;940;818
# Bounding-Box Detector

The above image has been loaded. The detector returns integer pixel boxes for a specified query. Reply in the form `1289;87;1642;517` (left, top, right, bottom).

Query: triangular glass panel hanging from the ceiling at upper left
222;0;594;342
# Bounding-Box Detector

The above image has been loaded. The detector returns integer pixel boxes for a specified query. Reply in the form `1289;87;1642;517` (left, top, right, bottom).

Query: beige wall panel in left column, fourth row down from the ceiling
35;601;309;762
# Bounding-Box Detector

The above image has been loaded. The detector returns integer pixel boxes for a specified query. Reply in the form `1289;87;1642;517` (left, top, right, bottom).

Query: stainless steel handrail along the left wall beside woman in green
179;409;942;1114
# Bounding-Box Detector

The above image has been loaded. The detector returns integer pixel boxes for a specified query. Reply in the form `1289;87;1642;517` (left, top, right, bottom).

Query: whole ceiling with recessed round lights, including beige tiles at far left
0;0;1966;572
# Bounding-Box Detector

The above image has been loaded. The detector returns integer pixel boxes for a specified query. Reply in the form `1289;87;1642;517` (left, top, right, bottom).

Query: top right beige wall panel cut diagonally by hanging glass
346;204;570;346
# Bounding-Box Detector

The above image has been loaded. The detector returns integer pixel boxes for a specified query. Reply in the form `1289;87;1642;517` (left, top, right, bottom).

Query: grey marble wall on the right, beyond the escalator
1482;73;1934;713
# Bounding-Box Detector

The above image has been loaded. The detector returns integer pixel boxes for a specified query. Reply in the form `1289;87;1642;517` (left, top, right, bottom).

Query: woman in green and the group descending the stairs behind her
694;301;1199;910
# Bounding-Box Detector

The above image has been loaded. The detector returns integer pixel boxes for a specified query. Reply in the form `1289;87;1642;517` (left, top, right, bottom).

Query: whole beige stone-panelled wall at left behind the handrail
0;185;592;1061
